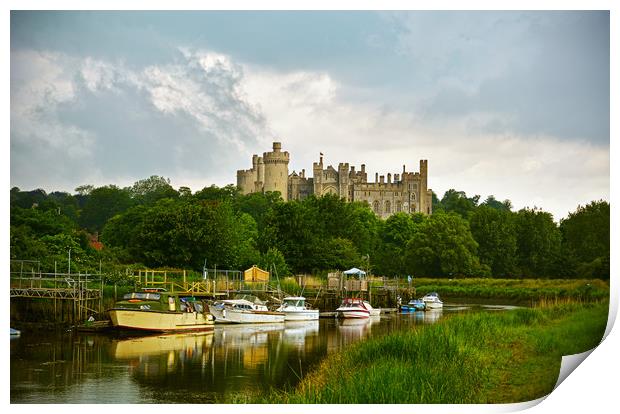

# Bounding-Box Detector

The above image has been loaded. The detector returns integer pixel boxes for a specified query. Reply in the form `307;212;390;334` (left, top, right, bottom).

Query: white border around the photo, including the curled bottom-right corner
0;0;620;414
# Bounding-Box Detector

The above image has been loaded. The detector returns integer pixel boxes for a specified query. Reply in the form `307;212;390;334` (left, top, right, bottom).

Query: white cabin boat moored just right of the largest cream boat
211;295;284;323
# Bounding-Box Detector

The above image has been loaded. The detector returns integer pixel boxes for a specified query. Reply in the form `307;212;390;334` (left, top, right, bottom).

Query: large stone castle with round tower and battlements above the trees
237;142;433;218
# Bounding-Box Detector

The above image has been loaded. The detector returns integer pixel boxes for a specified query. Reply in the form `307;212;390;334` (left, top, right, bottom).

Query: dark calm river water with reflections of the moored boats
11;305;509;403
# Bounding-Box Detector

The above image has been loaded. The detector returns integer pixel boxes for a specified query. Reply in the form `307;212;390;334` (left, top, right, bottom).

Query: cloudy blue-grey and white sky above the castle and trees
10;11;610;219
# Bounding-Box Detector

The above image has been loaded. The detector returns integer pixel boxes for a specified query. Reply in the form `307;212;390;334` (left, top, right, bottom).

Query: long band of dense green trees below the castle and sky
10;176;610;279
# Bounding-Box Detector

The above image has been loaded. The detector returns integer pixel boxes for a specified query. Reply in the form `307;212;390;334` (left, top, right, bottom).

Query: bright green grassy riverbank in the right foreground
234;302;608;404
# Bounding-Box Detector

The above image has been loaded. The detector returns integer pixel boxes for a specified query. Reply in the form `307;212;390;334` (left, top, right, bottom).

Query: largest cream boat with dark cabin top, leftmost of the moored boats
109;291;213;332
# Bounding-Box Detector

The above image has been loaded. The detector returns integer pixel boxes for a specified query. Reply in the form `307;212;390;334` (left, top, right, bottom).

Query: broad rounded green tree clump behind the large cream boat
102;199;258;269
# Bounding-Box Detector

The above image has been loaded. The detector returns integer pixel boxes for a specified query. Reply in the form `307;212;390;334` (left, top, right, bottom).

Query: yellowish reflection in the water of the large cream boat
112;331;213;359
